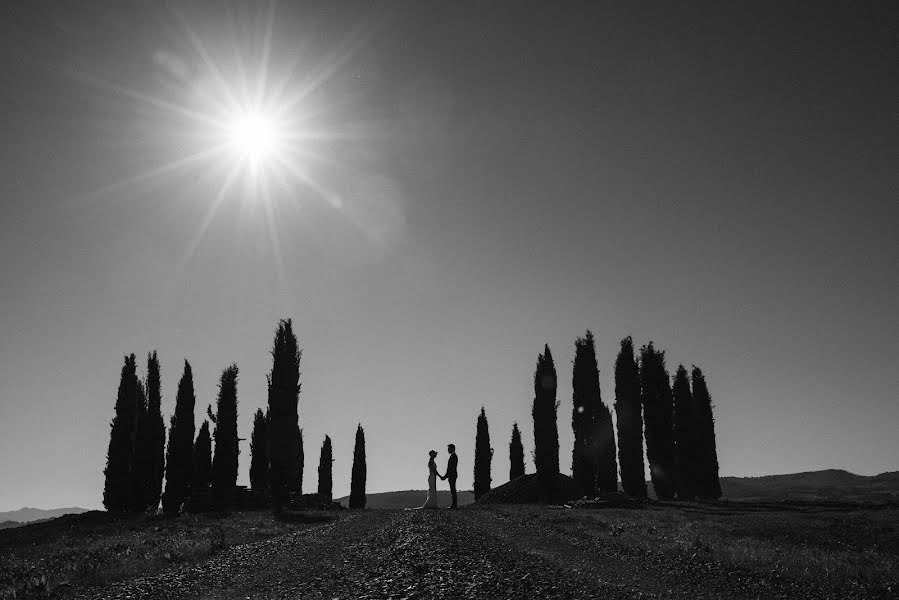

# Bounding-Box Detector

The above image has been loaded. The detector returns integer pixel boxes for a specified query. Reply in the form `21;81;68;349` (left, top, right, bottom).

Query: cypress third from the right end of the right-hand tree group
640;342;675;500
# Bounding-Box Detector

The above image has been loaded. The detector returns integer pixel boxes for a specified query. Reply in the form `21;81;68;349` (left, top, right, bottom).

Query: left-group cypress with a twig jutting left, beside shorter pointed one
212;364;240;510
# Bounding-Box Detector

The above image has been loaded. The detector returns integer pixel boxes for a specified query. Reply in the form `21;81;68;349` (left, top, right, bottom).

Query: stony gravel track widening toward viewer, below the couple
75;508;892;600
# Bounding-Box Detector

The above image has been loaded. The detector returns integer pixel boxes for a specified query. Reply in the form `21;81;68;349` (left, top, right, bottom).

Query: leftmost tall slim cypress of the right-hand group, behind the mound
531;344;559;502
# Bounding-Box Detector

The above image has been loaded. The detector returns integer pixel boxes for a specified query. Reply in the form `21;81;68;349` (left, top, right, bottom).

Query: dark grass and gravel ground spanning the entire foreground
0;504;899;600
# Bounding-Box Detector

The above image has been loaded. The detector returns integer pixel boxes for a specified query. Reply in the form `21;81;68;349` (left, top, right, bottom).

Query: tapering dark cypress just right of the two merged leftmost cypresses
162;360;196;514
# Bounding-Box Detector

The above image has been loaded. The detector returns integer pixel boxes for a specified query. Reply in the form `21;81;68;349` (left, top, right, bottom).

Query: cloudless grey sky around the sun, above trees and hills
0;2;899;510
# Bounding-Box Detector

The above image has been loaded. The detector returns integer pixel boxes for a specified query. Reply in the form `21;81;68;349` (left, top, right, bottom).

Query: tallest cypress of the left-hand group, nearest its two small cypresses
268;319;302;512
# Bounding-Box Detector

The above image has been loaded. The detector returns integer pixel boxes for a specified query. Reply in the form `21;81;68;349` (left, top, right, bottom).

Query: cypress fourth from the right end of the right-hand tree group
615;336;646;498
